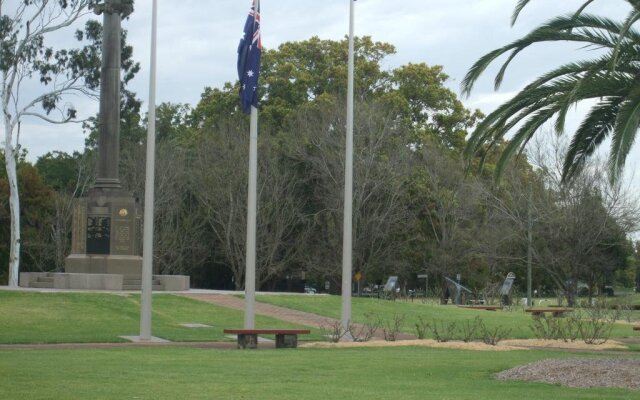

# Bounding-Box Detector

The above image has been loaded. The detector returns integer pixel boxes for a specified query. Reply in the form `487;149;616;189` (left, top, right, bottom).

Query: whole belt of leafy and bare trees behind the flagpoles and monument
0;37;637;302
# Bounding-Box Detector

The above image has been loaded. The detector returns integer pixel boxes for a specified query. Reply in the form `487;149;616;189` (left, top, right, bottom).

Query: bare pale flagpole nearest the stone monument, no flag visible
140;0;158;340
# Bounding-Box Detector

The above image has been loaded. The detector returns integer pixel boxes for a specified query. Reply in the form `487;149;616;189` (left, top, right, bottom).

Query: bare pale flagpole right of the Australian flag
341;0;355;332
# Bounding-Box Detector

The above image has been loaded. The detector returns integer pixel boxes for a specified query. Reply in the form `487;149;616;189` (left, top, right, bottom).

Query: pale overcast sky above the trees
3;0;638;188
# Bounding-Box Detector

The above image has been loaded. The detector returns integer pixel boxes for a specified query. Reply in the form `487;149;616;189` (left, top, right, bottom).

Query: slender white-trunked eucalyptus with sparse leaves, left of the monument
0;0;99;286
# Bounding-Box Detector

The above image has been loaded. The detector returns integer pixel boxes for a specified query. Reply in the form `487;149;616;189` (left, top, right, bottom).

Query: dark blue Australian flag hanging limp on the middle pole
238;0;262;114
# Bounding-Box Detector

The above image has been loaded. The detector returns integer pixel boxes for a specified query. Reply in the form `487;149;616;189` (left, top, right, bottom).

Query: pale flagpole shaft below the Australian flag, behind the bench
244;106;258;329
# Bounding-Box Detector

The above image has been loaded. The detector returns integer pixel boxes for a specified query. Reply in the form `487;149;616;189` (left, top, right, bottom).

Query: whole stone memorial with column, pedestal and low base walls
20;0;189;290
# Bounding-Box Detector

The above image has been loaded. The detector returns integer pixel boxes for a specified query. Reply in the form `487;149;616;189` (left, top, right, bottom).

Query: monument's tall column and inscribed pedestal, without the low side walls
65;0;142;275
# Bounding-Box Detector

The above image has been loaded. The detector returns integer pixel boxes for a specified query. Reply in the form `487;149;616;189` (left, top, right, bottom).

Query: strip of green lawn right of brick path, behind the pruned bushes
257;295;640;339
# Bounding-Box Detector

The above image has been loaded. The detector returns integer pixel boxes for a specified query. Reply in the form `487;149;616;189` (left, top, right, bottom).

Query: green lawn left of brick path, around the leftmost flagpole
0;291;320;344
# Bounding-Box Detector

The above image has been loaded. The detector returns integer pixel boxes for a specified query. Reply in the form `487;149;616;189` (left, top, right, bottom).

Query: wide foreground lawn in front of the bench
0;347;639;400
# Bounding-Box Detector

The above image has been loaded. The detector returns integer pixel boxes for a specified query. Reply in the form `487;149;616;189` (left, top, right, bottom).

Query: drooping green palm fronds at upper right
462;0;640;182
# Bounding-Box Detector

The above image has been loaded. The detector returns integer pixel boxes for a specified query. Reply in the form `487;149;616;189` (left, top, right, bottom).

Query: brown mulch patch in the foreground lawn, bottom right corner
496;358;640;390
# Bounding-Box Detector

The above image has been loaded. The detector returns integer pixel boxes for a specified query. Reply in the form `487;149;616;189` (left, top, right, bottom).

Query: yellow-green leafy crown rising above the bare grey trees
191;36;480;145
